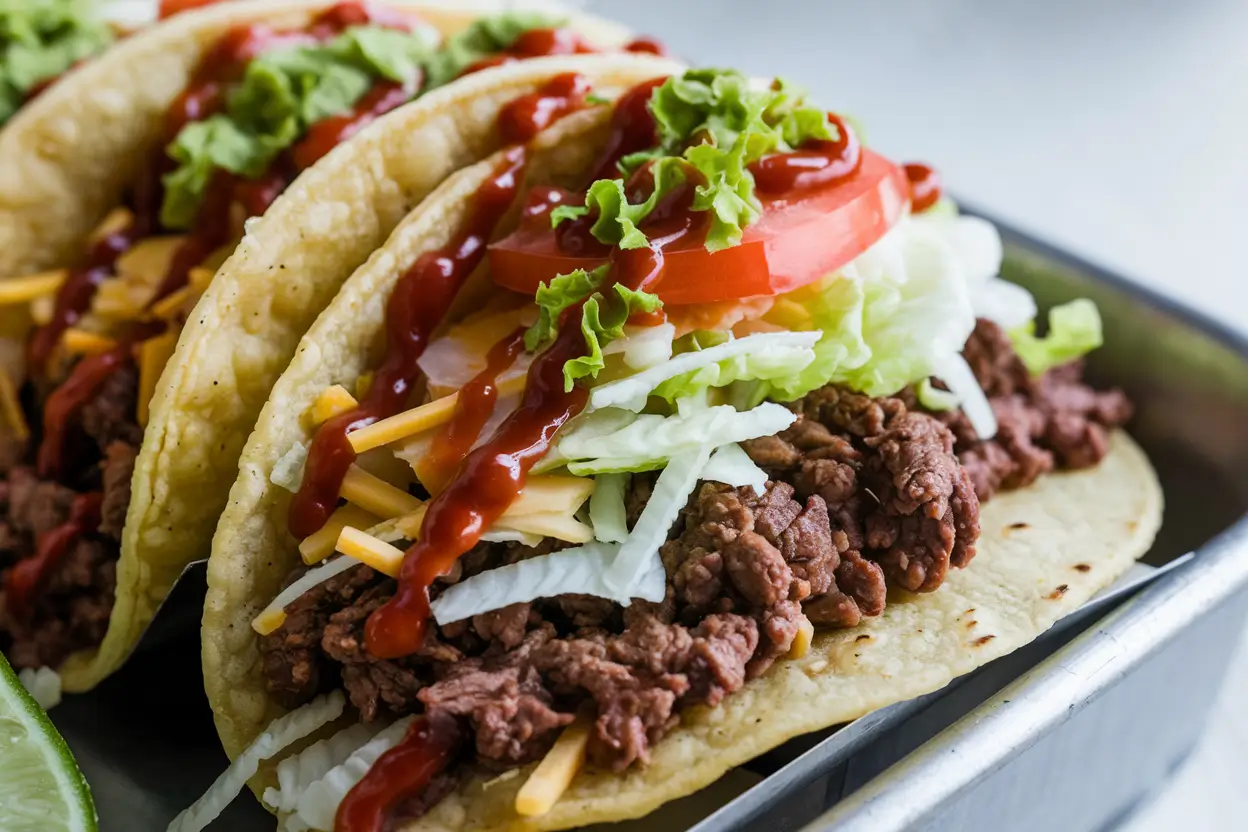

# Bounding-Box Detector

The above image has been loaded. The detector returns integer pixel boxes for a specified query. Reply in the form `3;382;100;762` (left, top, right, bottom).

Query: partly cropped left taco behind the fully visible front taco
0;0;671;691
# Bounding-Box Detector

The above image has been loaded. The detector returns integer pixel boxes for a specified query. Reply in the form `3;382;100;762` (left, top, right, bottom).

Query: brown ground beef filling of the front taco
261;323;1129;817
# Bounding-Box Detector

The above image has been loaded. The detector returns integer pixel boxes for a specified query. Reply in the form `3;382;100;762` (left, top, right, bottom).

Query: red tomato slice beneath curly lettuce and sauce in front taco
489;150;910;306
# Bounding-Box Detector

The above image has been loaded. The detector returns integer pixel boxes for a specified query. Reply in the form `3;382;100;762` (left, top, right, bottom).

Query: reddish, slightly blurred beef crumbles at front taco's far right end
936;321;1132;500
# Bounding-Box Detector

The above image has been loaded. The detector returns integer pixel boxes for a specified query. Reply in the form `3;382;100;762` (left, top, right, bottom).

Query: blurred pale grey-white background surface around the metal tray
582;0;1248;832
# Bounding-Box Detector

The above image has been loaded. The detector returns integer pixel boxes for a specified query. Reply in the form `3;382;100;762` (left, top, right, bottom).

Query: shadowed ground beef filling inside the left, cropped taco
0;367;142;667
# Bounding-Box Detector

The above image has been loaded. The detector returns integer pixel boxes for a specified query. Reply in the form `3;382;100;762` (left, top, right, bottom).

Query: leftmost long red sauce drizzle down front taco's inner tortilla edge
287;146;528;539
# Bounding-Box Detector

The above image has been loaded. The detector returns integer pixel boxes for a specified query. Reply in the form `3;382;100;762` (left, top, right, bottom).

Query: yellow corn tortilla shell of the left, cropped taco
0;0;678;691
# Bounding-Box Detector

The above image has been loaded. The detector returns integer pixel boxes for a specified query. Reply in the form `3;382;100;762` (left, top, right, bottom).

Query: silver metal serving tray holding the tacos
52;218;1248;832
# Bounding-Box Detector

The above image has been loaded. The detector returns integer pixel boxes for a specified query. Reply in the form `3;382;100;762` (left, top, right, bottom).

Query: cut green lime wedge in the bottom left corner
0;656;96;832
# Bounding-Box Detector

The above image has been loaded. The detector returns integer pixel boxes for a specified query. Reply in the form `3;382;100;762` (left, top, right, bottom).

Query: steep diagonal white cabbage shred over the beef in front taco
600;445;713;600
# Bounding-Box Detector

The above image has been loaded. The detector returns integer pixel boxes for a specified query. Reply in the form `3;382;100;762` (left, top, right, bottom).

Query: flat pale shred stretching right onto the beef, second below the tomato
558;402;796;476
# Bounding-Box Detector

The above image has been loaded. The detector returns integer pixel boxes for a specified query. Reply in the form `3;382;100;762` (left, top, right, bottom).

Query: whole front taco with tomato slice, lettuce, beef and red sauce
189;70;1161;832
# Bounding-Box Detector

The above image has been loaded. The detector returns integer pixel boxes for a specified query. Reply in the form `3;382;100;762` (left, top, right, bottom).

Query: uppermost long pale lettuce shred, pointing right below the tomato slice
589;332;822;413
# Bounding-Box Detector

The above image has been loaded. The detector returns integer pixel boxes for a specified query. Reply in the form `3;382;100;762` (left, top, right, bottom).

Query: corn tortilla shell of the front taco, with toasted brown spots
203;114;1162;831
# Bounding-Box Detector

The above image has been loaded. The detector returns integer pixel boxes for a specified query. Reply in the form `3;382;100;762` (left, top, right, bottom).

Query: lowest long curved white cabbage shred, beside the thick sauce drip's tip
431;541;668;624
